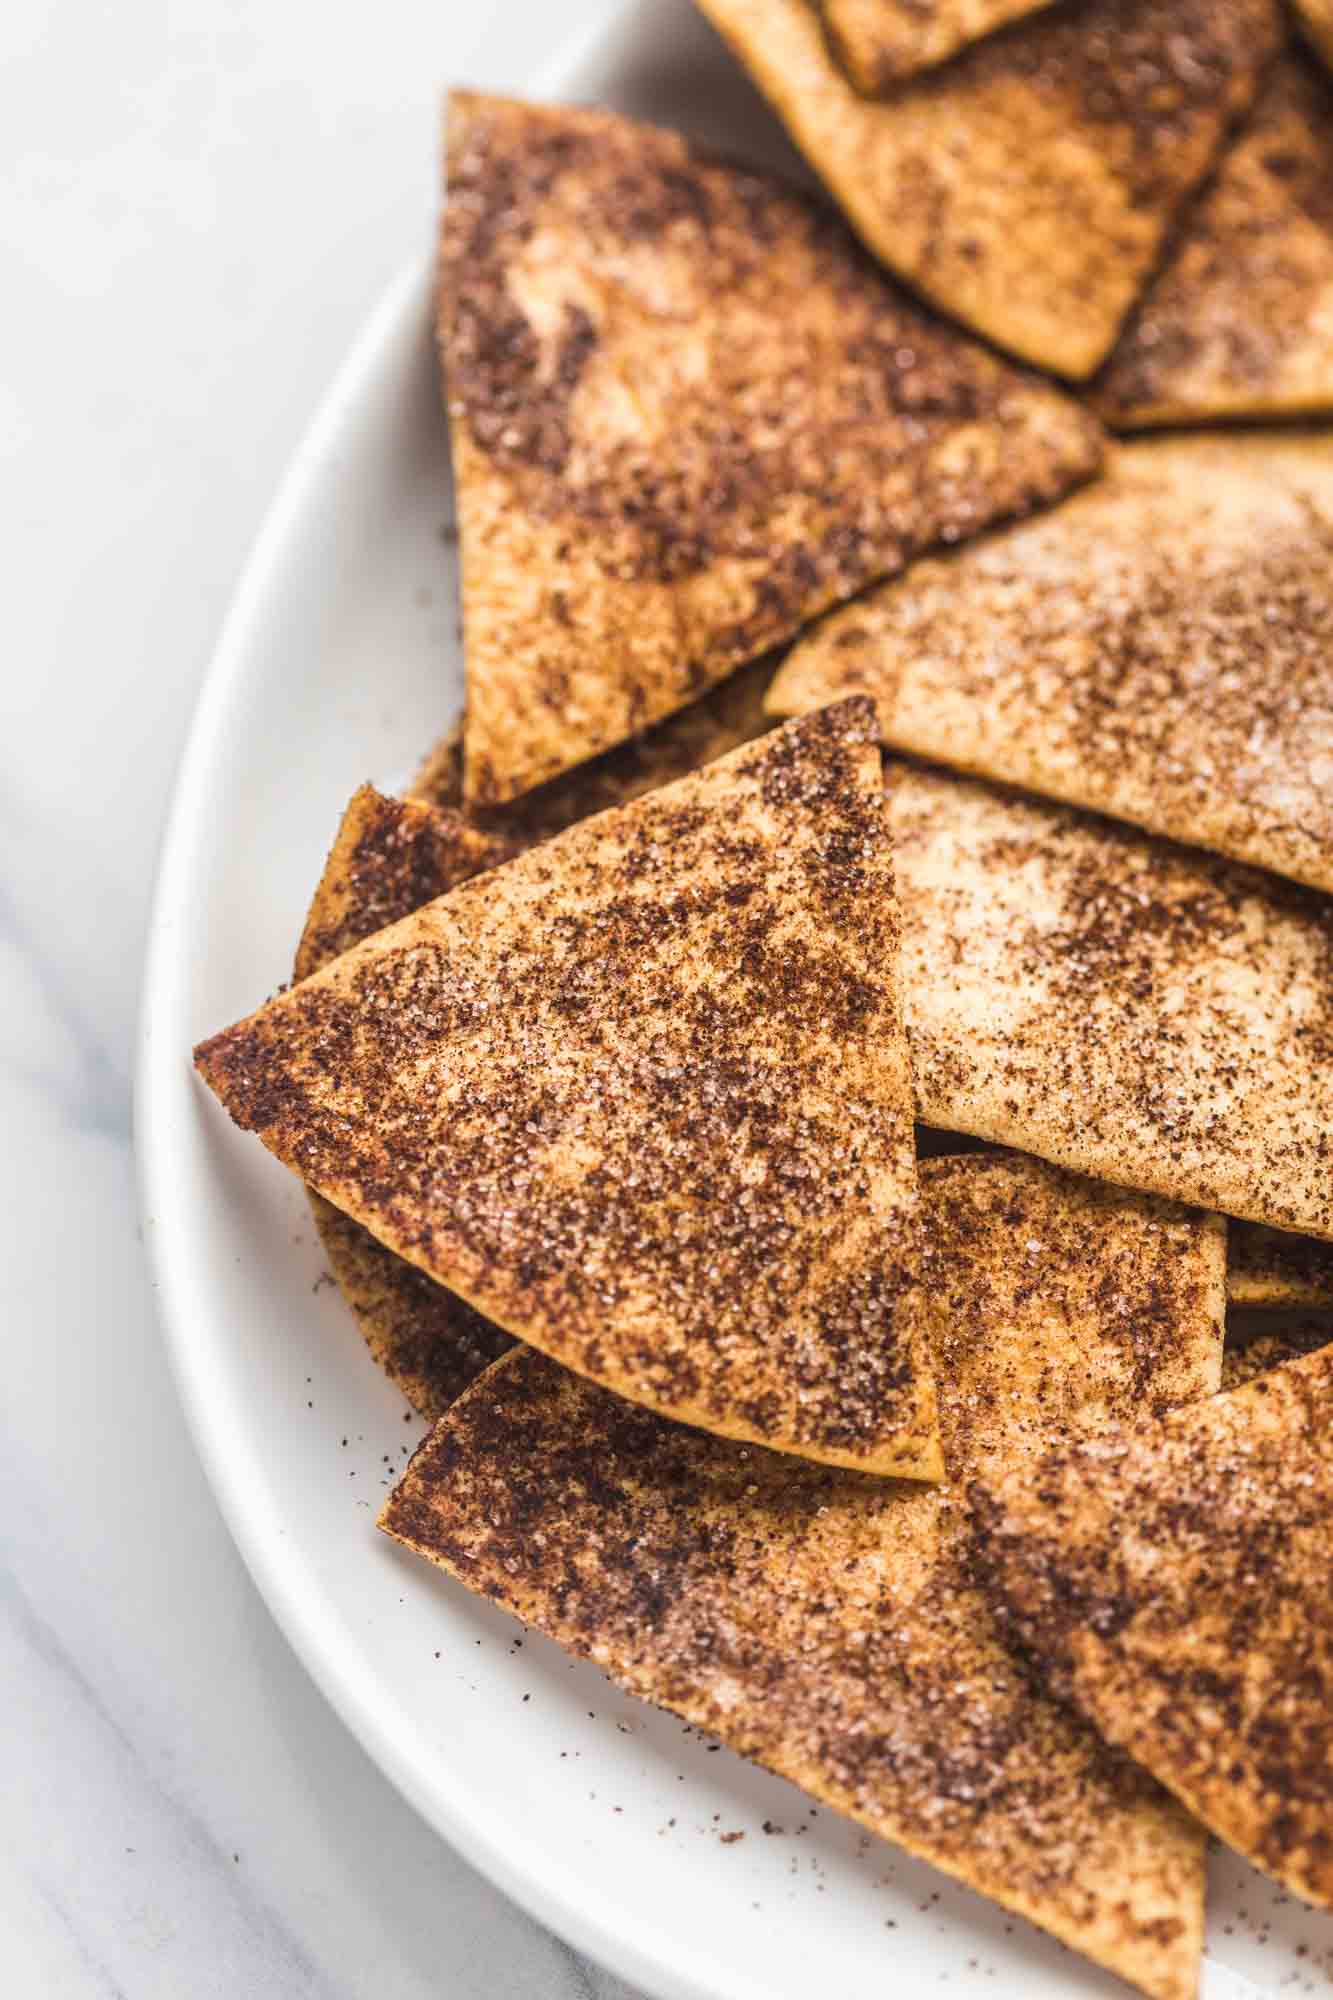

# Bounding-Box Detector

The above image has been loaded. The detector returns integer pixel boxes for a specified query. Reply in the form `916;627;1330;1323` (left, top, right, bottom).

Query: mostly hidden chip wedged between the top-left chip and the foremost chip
408;660;773;836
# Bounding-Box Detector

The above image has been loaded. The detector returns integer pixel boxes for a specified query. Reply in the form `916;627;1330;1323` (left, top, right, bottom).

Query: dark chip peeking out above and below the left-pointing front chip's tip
296;784;512;1416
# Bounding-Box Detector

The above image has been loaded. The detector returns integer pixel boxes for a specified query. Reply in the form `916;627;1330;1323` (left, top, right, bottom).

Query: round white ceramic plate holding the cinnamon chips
138;0;1333;2000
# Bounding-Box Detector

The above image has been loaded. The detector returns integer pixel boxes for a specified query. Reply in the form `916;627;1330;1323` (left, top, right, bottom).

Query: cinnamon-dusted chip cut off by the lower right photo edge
975;1348;1333;1906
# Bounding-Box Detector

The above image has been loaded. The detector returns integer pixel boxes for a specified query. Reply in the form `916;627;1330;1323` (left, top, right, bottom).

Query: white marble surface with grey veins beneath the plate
0;0;644;2000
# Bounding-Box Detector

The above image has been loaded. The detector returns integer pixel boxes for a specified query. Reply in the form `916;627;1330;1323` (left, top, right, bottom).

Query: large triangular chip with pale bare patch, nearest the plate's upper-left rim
440;94;1101;806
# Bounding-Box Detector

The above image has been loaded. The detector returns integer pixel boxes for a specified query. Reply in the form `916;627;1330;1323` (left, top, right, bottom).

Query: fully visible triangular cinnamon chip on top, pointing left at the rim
196;702;939;1478
